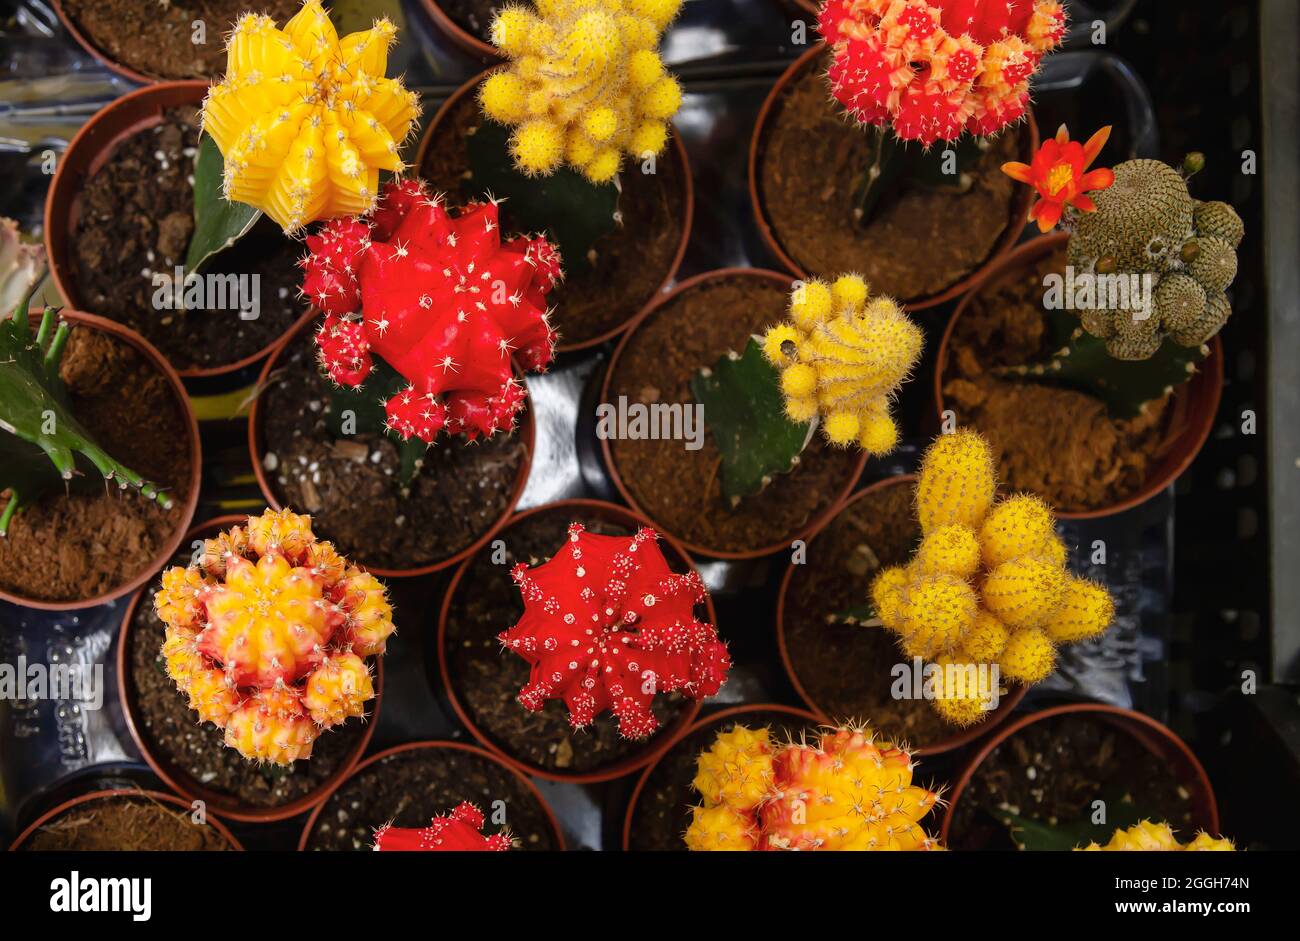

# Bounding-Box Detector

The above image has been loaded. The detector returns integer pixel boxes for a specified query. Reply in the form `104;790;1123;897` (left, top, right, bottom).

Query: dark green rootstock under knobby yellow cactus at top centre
464;121;619;272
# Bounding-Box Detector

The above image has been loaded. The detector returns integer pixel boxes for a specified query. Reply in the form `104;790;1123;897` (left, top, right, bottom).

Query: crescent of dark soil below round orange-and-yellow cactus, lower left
127;566;374;808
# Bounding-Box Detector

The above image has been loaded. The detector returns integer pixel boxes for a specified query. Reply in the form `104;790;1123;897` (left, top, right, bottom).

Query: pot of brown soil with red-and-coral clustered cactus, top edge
749;0;1065;309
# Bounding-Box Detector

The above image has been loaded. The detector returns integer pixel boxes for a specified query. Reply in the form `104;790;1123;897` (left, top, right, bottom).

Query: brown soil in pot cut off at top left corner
64;0;302;79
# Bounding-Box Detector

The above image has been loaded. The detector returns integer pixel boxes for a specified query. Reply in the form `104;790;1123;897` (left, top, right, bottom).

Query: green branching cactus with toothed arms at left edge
0;295;172;537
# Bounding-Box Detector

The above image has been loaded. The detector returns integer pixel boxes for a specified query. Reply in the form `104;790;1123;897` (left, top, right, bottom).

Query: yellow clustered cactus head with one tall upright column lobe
871;430;1114;725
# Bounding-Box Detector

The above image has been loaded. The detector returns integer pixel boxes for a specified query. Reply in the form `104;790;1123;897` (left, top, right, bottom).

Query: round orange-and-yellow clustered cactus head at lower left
153;509;393;764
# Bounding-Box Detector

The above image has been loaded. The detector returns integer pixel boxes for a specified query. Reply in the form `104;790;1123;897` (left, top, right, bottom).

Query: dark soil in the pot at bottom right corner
949;715;1195;850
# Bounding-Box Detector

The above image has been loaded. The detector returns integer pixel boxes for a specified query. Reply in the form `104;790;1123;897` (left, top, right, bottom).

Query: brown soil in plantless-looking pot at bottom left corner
22;794;231;853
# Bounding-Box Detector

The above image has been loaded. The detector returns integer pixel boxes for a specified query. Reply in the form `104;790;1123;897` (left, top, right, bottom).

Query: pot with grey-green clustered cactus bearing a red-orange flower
936;127;1244;515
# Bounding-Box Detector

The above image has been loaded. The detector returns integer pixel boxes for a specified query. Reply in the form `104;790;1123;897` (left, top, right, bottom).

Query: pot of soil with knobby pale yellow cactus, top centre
416;0;693;351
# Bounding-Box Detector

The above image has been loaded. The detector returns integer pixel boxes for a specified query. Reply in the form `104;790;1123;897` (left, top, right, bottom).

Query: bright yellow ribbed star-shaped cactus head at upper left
203;0;420;233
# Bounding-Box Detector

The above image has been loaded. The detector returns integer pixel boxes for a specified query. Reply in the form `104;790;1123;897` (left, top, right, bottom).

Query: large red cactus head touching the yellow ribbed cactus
302;179;562;443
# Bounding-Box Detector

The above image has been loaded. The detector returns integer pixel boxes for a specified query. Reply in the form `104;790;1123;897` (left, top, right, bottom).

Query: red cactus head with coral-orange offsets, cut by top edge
818;0;1066;147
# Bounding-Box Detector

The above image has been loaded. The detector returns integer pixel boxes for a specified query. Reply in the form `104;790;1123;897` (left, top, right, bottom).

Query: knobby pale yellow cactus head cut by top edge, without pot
480;0;683;183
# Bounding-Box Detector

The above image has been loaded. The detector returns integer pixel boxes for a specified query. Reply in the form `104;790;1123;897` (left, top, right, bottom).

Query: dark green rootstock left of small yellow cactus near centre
690;337;814;507
